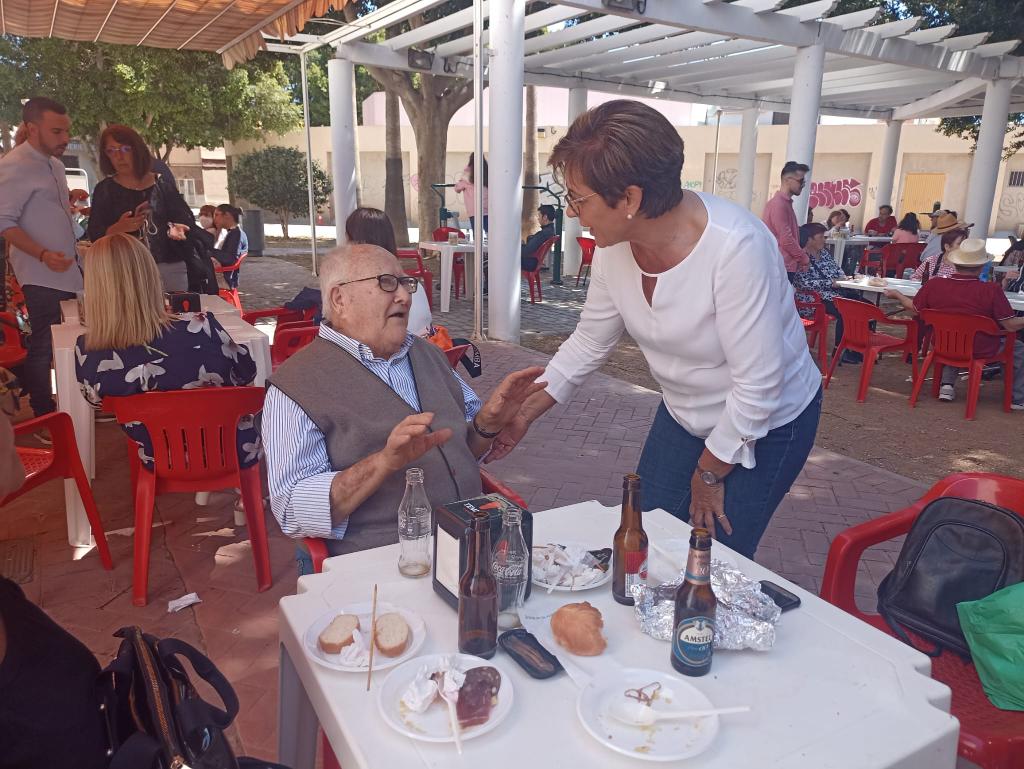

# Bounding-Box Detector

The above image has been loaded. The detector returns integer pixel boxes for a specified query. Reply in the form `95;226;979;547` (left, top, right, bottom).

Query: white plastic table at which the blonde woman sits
53;295;270;547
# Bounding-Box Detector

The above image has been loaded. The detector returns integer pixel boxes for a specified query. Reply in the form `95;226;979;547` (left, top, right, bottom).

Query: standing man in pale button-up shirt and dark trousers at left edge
0;97;82;417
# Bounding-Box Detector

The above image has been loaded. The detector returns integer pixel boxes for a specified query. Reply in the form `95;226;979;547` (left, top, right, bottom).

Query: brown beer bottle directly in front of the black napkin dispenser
459;513;498;659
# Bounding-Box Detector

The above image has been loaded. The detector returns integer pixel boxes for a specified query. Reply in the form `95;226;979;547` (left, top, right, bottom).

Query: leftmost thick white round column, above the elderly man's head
327;49;358;228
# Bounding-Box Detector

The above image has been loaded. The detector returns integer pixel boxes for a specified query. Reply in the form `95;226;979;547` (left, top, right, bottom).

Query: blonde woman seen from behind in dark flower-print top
75;233;259;468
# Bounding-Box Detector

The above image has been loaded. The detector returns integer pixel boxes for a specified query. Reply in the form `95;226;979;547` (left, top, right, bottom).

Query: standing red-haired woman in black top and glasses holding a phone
87;125;216;293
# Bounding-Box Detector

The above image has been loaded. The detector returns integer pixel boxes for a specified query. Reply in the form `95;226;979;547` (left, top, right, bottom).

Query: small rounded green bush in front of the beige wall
227;146;332;238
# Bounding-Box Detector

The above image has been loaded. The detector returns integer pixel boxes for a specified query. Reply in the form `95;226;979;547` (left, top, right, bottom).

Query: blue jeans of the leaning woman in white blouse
637;389;821;558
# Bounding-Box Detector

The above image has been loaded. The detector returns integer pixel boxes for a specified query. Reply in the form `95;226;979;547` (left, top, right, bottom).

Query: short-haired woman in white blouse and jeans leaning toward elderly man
487;100;821;557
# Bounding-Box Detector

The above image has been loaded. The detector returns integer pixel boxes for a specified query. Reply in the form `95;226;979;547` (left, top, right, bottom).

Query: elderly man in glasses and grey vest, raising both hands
262;245;544;573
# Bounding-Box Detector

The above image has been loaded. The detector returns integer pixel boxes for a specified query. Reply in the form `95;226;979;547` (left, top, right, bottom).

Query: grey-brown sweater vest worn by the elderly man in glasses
269;337;481;554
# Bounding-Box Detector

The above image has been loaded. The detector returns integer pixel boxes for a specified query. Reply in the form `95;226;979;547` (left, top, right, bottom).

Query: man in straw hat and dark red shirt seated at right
885;238;1024;411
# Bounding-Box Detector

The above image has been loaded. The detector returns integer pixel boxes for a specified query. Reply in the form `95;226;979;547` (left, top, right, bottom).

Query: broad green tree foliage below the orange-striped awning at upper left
0;36;302;158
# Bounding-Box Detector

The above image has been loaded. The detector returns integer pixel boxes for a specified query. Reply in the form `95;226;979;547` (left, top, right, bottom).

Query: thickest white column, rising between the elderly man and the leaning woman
487;0;526;342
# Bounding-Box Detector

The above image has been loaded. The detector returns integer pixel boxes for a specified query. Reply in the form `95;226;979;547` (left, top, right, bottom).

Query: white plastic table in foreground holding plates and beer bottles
278;501;958;769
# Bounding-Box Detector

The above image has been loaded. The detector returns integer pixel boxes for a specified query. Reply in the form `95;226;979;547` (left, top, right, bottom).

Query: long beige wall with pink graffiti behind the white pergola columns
225;124;1024;231
